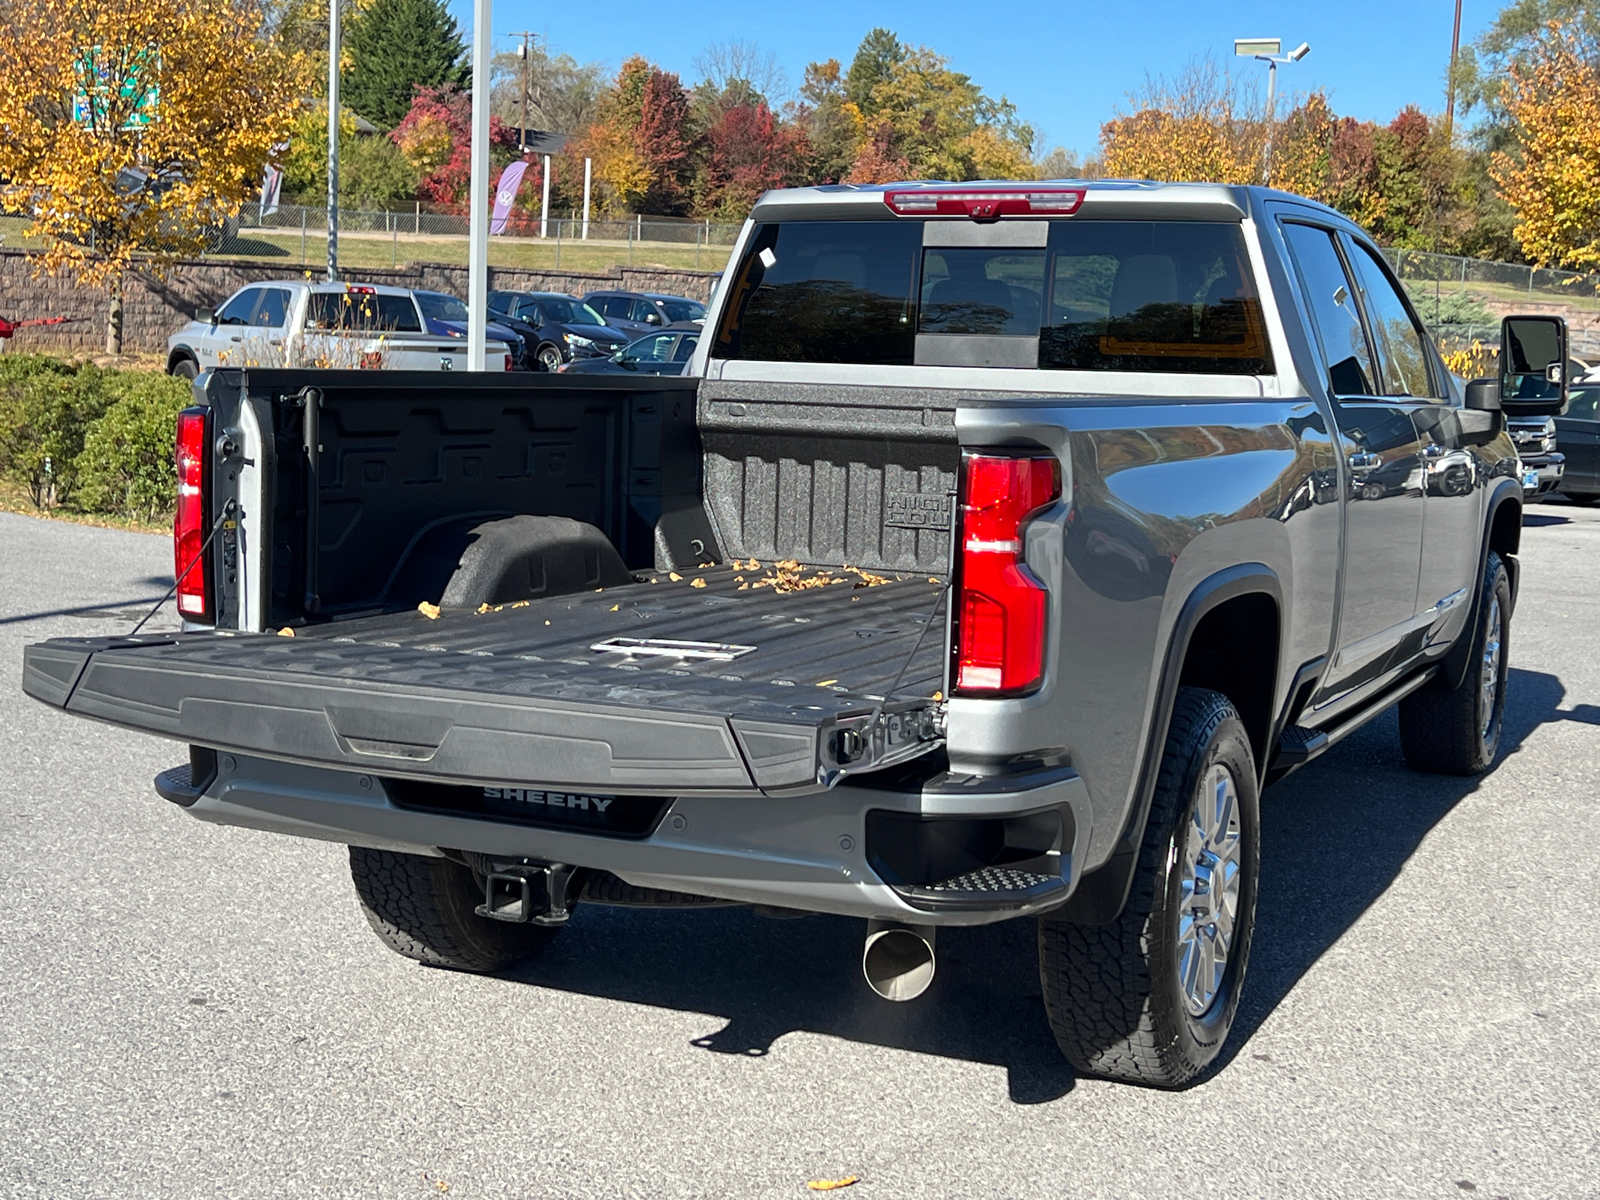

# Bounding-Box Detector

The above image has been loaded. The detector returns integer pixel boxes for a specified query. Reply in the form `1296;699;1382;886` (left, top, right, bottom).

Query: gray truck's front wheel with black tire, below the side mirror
1400;550;1512;774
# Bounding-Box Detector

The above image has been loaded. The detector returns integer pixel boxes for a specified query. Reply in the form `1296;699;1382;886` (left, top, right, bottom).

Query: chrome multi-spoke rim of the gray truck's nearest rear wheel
1178;763;1240;1016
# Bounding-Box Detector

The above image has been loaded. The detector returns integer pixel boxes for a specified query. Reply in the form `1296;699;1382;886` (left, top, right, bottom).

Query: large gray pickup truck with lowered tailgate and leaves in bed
24;182;1565;1088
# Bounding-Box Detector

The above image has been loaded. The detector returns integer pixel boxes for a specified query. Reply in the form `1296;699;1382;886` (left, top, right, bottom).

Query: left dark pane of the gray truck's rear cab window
714;221;922;366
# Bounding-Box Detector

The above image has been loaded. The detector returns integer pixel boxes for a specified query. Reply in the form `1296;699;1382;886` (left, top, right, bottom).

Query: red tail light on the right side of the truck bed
955;454;1061;696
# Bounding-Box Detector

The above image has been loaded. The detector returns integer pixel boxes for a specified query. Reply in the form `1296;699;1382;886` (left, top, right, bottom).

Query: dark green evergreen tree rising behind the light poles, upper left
344;0;467;130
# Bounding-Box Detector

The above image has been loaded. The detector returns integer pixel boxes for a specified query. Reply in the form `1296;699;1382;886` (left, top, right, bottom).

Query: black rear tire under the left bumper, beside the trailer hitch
350;846;560;971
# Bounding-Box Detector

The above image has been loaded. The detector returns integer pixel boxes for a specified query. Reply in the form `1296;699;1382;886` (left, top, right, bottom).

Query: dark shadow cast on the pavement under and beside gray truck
506;670;1561;1104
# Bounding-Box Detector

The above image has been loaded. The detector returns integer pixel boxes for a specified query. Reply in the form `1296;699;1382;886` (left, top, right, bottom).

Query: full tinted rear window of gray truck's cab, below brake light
712;221;1272;374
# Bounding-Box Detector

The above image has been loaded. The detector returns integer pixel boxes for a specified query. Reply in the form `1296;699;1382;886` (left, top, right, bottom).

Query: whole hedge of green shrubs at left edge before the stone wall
0;354;190;520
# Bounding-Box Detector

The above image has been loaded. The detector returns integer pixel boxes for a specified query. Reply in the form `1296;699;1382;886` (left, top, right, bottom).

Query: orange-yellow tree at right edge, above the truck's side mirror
1490;21;1600;270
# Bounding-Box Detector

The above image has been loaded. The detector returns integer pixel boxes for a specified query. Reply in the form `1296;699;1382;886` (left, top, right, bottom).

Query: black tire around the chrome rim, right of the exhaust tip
1038;688;1261;1088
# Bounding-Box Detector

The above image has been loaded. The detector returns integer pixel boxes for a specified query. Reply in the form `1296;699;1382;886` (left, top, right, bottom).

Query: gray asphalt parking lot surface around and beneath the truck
0;504;1600;1200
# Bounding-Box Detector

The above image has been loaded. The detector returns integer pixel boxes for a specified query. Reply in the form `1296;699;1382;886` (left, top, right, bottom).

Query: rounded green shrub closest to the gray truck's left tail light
75;373;190;520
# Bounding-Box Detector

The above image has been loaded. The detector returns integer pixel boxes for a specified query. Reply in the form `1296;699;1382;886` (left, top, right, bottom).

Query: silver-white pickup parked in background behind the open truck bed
166;280;512;379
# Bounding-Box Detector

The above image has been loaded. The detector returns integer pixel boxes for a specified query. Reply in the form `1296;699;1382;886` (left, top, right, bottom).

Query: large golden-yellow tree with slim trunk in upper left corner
0;0;301;354
